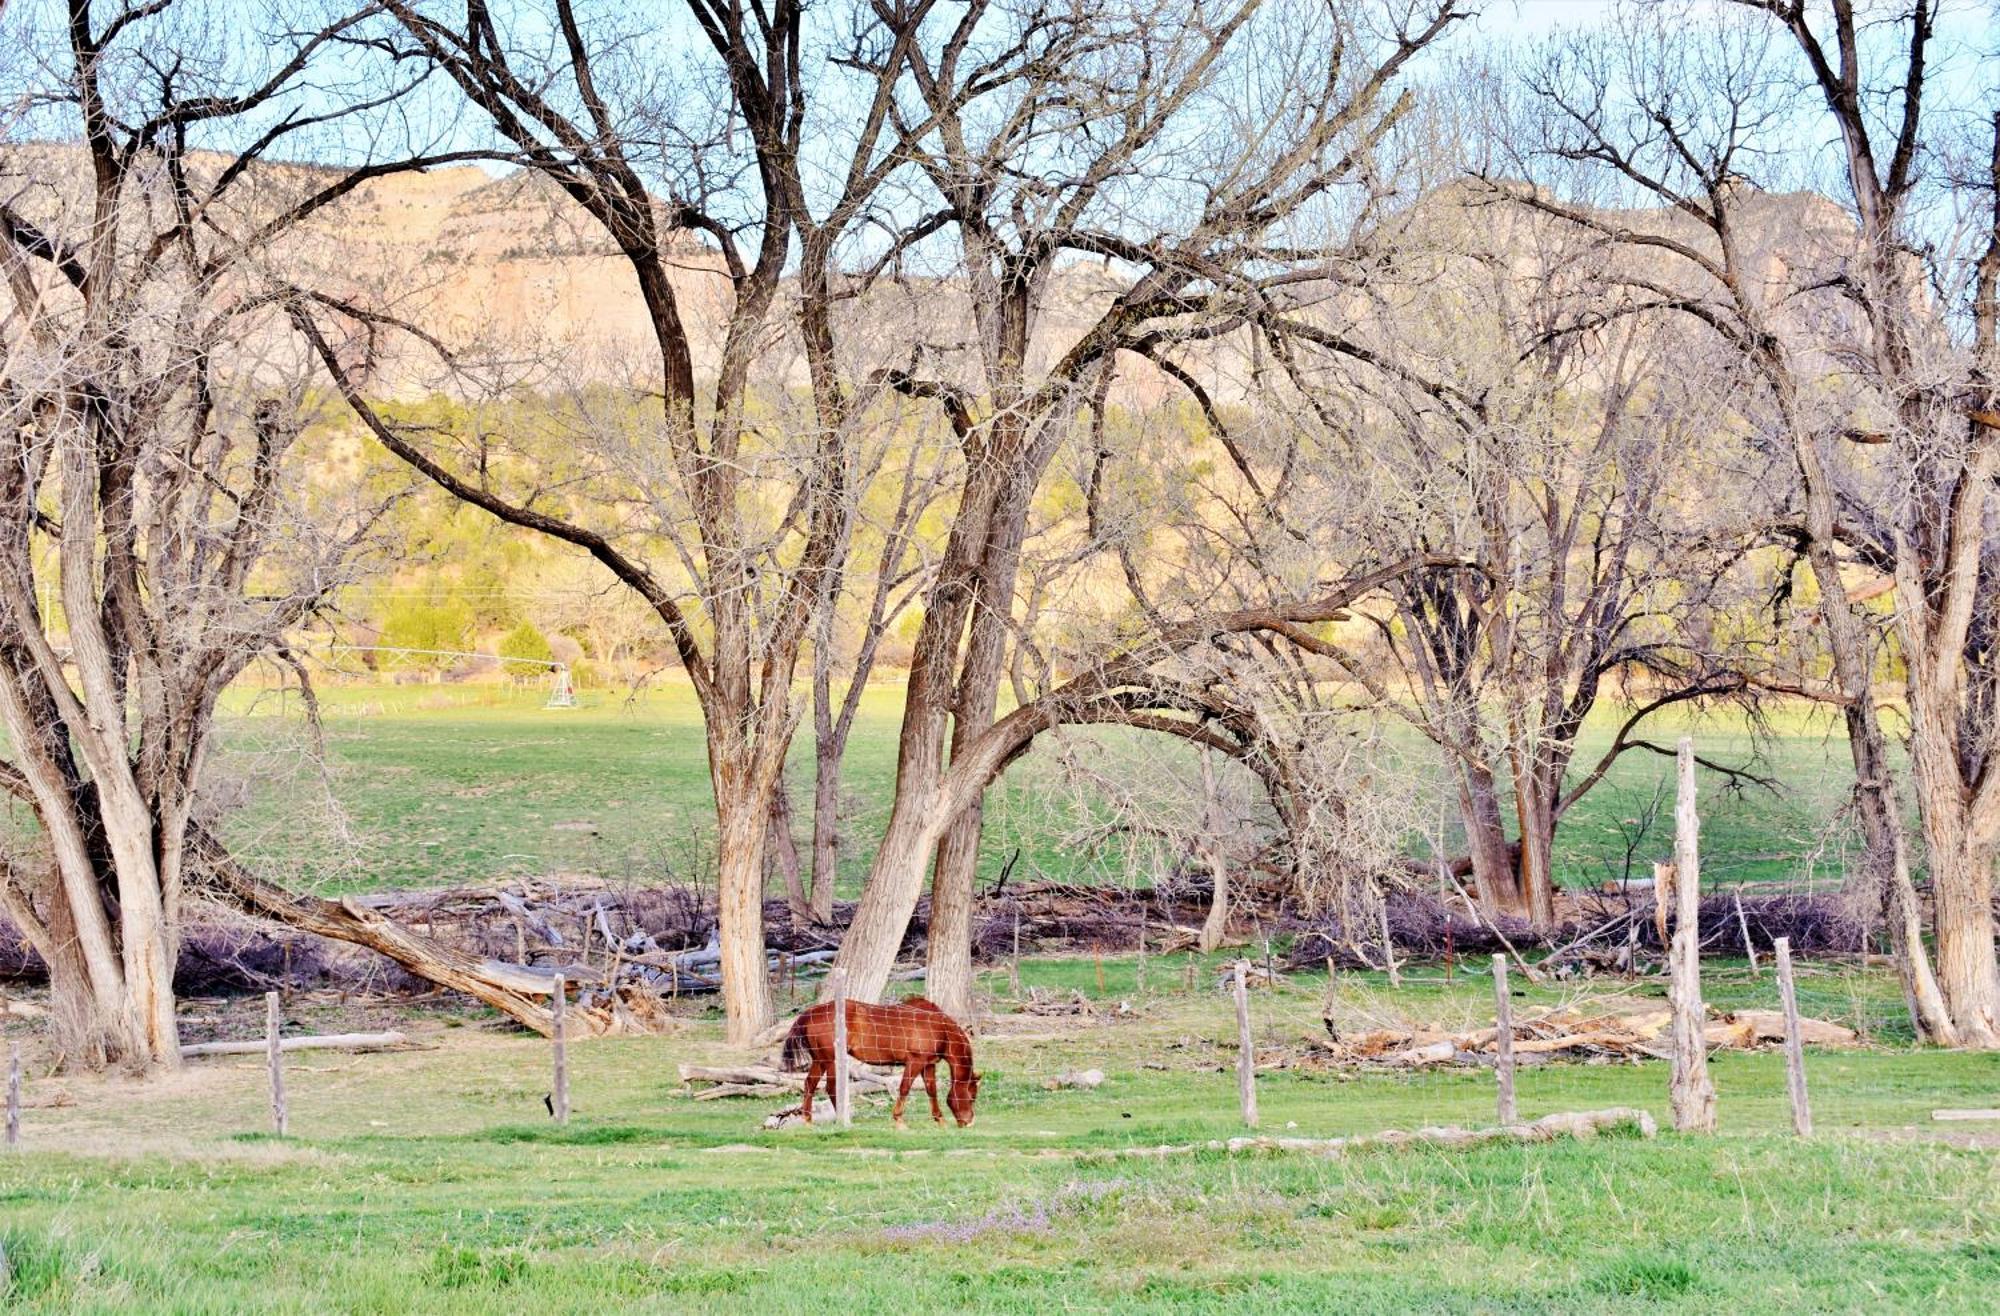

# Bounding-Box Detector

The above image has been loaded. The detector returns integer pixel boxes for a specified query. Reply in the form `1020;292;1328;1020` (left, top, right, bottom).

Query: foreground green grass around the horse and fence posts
0;960;2000;1312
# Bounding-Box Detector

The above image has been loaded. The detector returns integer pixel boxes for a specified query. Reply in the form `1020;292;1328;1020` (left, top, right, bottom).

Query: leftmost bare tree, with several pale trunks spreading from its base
0;0;524;1070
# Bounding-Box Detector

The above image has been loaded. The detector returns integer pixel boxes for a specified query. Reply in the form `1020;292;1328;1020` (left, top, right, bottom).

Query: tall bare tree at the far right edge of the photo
1514;4;2000;1046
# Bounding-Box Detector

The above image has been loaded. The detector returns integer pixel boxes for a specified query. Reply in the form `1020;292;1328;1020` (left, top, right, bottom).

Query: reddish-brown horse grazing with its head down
784;996;980;1128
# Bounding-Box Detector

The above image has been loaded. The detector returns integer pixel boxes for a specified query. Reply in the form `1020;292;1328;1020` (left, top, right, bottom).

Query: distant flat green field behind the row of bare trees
224;684;1852;894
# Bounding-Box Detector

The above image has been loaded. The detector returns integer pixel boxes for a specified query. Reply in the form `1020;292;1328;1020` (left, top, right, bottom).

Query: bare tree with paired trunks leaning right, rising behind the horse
840;0;1460;1014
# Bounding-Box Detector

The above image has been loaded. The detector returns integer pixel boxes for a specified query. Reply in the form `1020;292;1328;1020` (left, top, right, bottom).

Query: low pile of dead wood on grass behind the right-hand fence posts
1304;1000;1860;1070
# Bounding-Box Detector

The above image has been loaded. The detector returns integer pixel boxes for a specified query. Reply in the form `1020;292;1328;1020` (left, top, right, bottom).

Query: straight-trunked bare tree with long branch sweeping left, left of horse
334;0;930;1042
